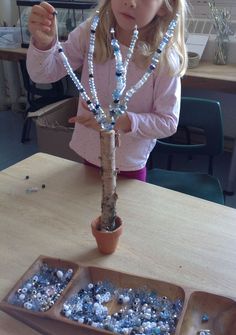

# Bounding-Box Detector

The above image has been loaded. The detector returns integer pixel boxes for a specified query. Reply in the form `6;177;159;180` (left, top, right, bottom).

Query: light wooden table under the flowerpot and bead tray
0;153;236;335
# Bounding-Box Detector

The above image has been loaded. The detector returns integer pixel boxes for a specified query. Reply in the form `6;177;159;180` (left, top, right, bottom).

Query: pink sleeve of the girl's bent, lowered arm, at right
128;61;181;139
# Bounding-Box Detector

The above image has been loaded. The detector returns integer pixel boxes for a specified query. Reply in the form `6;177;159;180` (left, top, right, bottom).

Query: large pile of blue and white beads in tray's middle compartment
61;281;183;335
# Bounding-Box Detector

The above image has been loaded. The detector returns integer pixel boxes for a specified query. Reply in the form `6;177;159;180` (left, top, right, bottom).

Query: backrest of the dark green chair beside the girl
156;97;224;156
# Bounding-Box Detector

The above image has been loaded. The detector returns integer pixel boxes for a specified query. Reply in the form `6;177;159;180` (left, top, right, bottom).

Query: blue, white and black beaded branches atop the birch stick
54;12;178;130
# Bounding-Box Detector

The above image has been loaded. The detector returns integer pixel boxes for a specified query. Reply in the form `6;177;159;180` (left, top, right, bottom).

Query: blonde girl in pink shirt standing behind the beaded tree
27;0;187;181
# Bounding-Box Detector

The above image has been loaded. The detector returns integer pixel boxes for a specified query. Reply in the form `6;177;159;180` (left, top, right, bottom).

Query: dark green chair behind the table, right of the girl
147;97;224;204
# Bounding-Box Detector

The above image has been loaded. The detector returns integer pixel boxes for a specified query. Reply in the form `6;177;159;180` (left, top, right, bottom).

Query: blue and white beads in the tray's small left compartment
10;263;73;312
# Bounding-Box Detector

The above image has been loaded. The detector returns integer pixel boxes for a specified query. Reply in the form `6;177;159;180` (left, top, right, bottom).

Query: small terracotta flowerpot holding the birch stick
91;216;123;254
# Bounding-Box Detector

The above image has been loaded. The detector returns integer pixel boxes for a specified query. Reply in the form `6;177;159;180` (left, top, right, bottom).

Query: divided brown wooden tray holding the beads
0;256;236;335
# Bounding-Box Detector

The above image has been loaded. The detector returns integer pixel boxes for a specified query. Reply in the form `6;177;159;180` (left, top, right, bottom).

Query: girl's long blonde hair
88;0;187;76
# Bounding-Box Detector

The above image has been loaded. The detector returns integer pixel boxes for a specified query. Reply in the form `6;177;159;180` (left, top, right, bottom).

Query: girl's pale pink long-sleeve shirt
27;22;181;171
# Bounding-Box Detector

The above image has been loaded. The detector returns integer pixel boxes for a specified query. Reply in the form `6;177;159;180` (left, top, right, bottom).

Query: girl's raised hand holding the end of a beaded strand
28;2;56;50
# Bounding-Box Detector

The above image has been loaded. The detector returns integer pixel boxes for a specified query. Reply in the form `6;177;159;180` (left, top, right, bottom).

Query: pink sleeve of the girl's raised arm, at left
26;22;87;84
